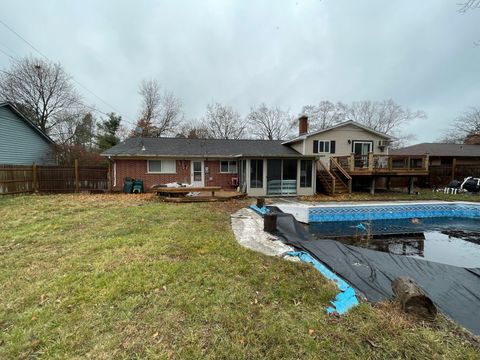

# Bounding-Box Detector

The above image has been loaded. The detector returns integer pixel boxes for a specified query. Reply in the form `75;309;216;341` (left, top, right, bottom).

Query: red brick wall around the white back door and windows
112;160;238;190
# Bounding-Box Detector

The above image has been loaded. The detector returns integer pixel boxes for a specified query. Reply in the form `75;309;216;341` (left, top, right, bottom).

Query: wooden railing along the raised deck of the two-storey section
332;153;428;172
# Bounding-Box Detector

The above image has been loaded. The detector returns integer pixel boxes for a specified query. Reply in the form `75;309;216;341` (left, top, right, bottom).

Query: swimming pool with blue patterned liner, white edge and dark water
278;201;480;267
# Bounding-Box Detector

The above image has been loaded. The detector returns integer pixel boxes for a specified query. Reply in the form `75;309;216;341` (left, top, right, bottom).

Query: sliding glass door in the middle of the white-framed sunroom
267;159;297;195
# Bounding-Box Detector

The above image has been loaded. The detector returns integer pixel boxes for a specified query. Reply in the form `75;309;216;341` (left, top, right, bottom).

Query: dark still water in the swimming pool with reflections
307;218;480;267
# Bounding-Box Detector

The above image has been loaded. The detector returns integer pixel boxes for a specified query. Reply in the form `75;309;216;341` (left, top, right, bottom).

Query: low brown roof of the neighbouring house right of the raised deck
390;143;480;157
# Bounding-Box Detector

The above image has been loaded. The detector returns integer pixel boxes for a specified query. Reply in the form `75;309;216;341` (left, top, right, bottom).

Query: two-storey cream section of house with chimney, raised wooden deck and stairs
283;116;428;194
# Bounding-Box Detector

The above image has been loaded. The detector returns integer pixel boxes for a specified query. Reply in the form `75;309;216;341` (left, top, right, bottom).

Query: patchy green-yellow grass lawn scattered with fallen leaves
0;195;479;359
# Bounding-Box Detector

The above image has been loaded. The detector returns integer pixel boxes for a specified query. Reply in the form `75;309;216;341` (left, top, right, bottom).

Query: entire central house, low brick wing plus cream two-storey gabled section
102;116;424;196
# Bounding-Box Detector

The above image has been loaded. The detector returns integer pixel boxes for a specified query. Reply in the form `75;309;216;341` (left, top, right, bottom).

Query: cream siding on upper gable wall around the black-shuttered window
292;125;387;164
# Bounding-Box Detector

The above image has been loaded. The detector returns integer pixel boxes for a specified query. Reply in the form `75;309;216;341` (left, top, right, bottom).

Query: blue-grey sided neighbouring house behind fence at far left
0;102;55;165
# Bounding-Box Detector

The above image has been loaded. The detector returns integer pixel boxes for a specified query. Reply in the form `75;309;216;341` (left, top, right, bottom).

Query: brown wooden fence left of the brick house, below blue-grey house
0;161;111;195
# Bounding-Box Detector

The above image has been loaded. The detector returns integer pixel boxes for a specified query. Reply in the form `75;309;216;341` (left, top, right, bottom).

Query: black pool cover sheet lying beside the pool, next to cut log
271;208;480;335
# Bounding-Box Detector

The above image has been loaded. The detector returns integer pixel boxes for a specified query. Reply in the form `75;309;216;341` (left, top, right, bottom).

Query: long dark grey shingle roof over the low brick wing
101;137;303;158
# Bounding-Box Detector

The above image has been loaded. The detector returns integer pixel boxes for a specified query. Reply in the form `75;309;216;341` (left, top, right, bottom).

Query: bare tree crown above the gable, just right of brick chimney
302;100;346;130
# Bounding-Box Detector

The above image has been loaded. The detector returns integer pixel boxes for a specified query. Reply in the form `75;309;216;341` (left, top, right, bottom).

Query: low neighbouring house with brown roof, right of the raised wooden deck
392;142;480;187
